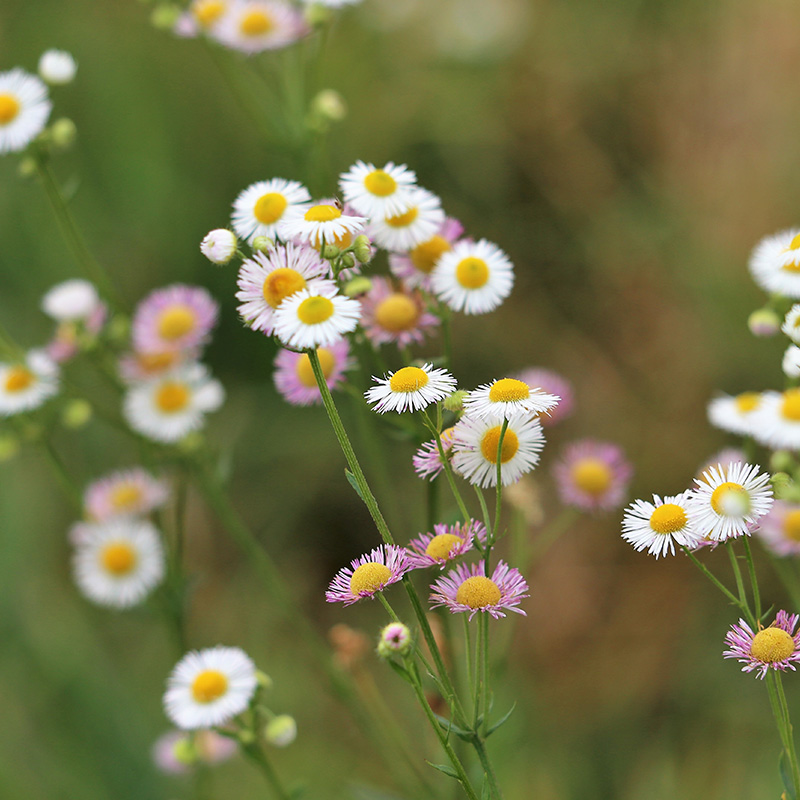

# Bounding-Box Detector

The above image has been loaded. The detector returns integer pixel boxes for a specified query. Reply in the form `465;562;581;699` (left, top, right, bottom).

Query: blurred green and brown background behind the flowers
0;0;800;800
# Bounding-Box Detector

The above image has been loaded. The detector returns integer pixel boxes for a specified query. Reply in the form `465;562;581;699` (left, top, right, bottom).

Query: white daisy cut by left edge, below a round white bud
0;69;53;155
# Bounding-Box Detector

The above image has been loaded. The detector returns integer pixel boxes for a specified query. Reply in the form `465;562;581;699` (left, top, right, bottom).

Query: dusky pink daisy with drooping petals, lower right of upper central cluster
361;277;439;347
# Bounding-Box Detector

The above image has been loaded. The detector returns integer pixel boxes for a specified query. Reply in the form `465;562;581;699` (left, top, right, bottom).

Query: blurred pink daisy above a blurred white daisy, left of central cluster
132;283;219;353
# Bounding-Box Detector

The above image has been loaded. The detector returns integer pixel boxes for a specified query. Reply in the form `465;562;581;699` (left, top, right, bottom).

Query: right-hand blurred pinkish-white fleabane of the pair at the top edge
209;0;311;54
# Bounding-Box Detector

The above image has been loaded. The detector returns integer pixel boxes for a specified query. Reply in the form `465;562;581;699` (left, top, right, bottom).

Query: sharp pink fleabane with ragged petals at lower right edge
722;611;800;680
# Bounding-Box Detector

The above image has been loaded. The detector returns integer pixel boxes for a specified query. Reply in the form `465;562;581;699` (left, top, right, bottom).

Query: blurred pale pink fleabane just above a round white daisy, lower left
83;467;169;522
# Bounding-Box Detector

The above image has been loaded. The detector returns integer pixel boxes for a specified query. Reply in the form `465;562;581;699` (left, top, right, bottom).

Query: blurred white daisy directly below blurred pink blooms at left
124;363;225;442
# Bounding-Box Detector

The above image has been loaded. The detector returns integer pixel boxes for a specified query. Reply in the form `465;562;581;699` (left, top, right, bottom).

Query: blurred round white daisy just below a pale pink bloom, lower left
72;518;165;608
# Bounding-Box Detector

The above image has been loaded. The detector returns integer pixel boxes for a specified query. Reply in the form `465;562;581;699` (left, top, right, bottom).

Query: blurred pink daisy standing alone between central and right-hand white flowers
553;439;633;511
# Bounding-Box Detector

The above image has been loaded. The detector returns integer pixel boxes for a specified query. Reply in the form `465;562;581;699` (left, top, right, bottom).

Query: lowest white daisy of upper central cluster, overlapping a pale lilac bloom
273;282;361;350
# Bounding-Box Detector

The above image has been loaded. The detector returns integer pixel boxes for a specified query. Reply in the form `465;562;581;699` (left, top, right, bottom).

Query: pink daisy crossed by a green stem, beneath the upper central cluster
273;339;353;406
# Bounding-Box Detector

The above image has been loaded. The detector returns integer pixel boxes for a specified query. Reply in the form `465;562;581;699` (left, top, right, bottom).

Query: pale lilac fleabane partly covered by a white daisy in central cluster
236;242;336;336
